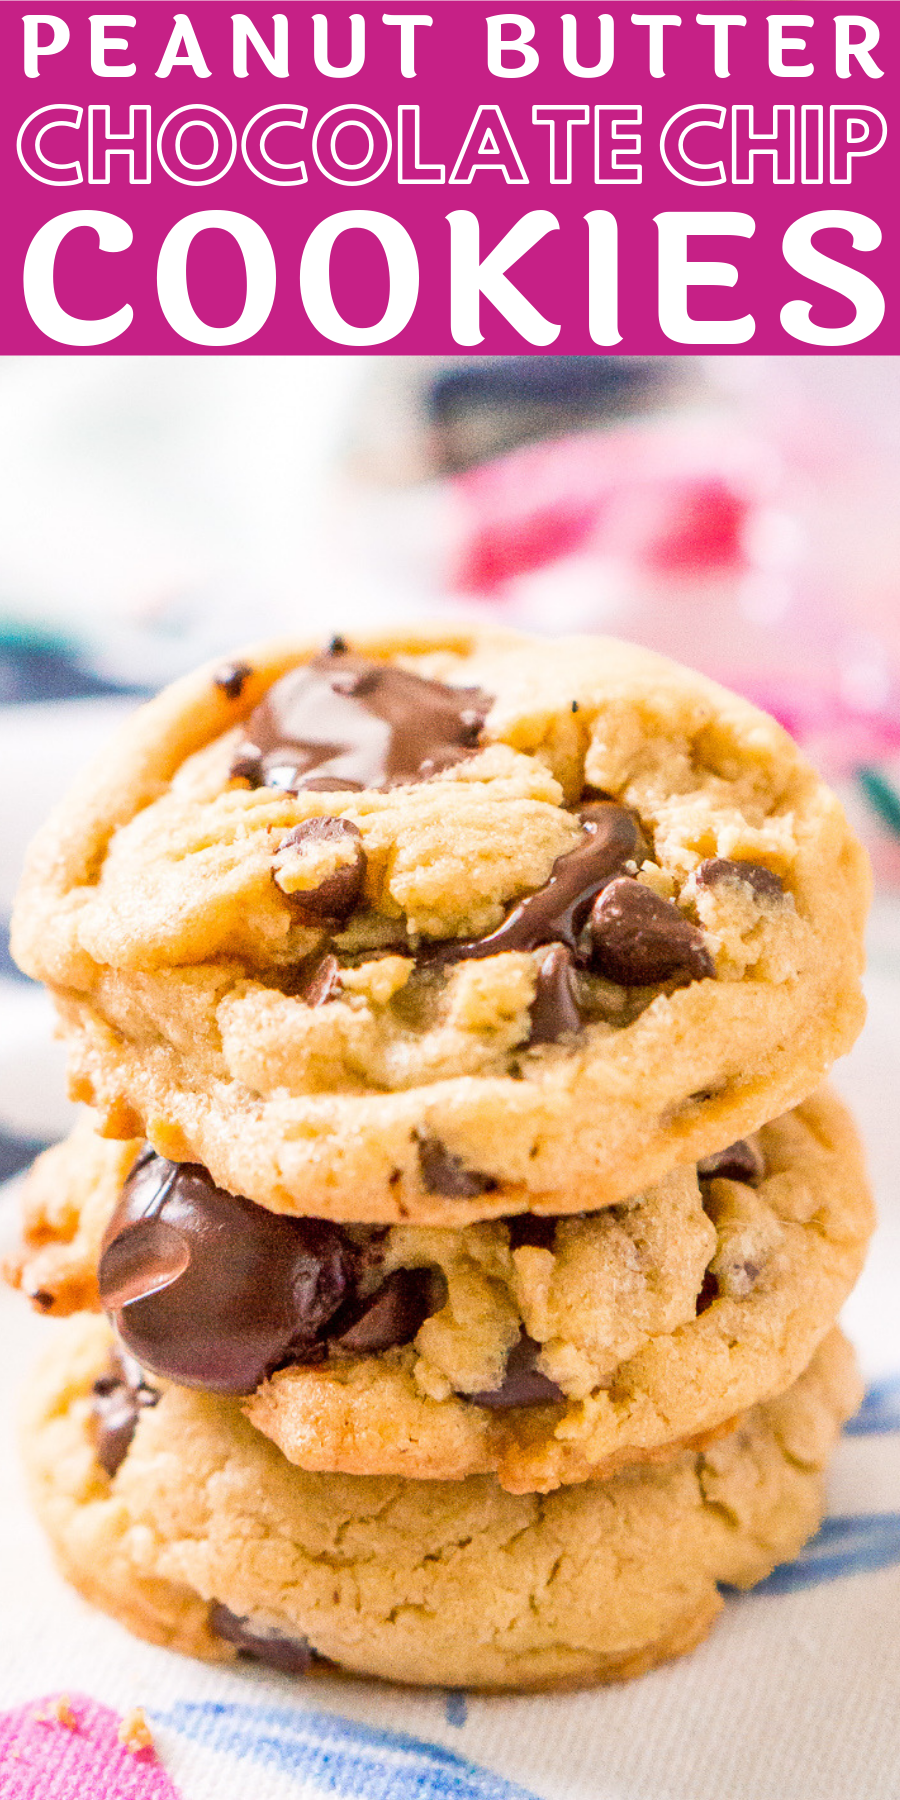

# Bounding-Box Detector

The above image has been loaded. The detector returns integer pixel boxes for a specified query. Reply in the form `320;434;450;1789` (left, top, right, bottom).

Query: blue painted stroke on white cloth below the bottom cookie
153;1701;538;1800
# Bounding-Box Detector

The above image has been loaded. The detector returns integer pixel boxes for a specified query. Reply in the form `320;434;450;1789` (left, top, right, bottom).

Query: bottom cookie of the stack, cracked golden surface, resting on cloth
25;1318;859;1688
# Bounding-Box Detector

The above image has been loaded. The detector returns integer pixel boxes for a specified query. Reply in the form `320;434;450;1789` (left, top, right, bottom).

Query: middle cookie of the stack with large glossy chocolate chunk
16;1091;873;1492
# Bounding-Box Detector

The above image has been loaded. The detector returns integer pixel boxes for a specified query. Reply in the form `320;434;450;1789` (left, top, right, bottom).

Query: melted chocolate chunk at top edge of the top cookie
230;639;491;794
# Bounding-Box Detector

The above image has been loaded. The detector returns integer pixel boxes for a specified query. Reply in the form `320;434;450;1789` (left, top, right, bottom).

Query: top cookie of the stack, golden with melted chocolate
13;630;868;1224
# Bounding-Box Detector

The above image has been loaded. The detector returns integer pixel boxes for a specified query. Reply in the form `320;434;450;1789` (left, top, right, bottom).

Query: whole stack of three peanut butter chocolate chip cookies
9;630;871;1688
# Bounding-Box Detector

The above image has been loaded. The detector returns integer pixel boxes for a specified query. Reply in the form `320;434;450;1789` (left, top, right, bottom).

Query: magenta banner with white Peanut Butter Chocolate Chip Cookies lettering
0;0;900;355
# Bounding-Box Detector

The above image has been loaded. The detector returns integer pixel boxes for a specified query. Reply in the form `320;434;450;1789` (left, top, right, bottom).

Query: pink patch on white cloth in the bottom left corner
0;1694;182;1800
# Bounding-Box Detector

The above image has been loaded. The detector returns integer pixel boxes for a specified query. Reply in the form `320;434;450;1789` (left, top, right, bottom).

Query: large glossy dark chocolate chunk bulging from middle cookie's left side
99;1154;356;1393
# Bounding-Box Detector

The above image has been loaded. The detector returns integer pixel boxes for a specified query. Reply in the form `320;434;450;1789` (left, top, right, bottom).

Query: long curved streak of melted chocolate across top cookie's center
425;801;641;963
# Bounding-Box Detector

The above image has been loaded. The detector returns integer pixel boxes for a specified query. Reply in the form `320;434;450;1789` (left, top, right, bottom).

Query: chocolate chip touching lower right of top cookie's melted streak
590;875;715;988
